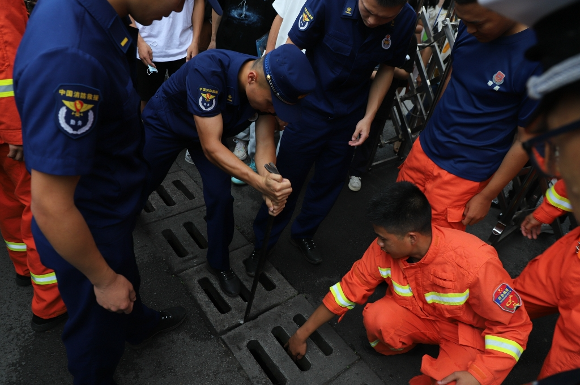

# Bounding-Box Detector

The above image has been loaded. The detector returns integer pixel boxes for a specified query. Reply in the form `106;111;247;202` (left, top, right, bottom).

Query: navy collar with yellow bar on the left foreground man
77;0;133;54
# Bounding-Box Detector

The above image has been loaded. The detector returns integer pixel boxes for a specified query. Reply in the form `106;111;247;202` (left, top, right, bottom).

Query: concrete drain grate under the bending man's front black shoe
179;245;297;334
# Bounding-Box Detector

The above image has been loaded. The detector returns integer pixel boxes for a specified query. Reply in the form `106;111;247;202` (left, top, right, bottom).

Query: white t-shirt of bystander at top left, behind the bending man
135;0;194;62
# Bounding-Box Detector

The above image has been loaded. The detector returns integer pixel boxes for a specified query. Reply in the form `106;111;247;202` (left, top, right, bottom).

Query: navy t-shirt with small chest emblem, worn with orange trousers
421;23;541;182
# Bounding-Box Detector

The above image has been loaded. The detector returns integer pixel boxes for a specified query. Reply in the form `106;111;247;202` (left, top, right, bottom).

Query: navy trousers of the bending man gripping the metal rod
143;109;234;270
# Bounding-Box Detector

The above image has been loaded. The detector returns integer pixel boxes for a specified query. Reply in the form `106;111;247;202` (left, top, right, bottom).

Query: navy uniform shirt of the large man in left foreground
14;0;148;235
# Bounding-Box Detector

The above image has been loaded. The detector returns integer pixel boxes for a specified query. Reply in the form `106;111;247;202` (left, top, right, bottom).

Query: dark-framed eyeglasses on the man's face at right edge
522;120;580;178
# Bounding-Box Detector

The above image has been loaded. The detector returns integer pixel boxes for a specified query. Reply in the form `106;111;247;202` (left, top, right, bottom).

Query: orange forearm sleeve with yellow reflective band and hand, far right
521;179;572;239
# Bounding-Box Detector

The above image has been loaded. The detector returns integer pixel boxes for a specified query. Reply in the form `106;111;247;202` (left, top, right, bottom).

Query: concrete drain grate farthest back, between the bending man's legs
139;171;205;223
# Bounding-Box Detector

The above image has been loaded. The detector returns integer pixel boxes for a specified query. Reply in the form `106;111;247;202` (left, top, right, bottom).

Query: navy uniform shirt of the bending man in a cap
143;49;258;141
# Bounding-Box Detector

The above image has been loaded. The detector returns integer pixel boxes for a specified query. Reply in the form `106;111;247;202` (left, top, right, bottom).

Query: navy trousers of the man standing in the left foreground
31;220;159;385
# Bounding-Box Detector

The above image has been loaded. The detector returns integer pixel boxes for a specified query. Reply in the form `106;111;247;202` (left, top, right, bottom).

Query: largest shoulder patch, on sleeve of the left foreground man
54;84;101;139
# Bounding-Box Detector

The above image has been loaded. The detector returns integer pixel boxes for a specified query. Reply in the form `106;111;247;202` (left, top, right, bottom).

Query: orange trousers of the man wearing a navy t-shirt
397;137;491;231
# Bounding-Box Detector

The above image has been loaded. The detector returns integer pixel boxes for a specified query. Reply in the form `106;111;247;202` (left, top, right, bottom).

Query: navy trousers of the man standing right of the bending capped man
254;109;364;250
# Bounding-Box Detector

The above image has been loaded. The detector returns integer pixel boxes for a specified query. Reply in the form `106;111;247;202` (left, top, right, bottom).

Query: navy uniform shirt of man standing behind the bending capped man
288;0;417;118
